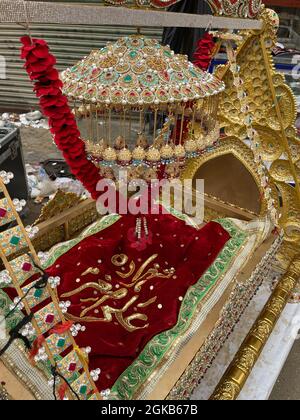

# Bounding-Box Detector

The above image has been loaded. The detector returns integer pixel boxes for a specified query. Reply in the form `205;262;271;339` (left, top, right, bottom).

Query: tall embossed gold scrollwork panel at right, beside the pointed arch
199;9;300;246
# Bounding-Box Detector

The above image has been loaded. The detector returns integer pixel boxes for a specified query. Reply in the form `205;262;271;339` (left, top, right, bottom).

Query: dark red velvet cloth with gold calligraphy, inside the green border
47;214;230;389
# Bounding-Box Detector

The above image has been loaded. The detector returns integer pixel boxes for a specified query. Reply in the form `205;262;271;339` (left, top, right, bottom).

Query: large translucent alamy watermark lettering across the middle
97;171;204;225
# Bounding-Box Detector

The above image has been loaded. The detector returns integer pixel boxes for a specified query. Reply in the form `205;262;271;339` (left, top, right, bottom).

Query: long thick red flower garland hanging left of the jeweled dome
21;36;101;199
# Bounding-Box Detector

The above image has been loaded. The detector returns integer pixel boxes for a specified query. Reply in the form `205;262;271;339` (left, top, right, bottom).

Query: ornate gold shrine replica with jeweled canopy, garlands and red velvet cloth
0;0;300;400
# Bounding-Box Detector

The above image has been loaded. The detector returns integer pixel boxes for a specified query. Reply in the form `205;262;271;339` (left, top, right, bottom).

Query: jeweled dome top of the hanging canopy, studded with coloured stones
62;36;224;108
